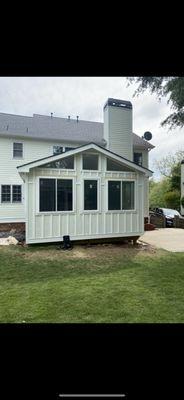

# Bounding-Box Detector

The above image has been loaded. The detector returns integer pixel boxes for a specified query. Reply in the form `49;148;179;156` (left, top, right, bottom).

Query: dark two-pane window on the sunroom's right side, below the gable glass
108;181;135;210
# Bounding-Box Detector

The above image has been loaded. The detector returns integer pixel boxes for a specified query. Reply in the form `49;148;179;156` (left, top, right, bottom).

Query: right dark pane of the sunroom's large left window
57;179;73;211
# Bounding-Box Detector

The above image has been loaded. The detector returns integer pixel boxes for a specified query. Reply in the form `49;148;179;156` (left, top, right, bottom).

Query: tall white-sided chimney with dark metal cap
104;98;133;161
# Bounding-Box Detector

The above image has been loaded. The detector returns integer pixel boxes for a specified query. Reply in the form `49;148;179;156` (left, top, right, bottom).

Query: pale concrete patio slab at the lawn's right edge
139;228;184;252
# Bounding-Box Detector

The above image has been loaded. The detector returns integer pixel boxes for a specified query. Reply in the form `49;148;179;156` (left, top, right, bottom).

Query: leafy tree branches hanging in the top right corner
127;76;184;129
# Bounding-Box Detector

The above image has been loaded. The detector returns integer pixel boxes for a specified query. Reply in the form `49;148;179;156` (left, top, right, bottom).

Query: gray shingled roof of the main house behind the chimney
0;113;154;148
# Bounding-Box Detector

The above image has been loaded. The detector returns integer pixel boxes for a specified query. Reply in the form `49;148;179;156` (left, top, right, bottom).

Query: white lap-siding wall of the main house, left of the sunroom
0;137;77;223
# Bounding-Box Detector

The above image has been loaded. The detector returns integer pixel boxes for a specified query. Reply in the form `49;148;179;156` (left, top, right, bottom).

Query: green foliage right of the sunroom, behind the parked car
149;178;170;209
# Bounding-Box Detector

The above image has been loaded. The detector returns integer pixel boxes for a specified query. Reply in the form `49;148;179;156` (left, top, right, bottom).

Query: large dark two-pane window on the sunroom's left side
40;178;73;211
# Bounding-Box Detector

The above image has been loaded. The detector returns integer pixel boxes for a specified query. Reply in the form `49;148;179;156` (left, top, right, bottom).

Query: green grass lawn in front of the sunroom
0;244;184;323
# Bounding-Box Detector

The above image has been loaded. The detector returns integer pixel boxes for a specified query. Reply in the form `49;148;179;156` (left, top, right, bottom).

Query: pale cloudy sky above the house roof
0;77;184;179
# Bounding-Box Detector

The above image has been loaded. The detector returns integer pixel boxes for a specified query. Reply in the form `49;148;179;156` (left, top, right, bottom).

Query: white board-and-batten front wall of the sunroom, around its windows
26;154;144;243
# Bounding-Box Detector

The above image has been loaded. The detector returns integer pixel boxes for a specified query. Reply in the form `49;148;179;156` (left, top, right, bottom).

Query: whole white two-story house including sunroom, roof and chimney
0;99;154;243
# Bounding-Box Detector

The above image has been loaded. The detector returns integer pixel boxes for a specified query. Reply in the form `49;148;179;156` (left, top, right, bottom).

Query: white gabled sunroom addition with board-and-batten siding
17;143;152;243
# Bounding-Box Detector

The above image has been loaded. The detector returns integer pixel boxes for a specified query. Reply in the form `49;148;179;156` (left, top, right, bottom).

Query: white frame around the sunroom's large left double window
36;177;76;215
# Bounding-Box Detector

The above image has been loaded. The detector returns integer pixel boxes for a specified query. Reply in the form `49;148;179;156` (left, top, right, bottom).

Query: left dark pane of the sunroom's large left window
40;179;56;211
